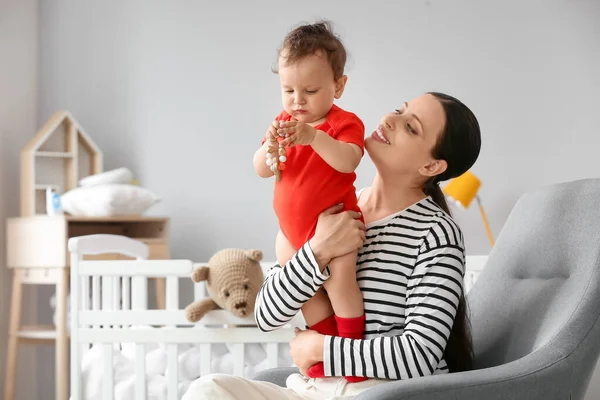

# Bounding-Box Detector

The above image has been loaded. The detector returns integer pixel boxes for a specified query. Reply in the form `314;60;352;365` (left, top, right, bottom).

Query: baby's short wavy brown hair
273;21;346;80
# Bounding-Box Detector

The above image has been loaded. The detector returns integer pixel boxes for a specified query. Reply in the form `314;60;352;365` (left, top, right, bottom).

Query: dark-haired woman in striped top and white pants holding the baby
184;93;481;400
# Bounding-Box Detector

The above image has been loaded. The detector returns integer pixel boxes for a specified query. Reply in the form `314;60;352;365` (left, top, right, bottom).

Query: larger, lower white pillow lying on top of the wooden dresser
60;184;160;217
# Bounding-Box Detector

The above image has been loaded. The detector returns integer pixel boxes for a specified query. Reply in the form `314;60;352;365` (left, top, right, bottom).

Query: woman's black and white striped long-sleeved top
255;197;465;379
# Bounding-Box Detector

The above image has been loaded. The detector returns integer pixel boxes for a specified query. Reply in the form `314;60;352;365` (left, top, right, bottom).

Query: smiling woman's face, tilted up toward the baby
365;94;446;180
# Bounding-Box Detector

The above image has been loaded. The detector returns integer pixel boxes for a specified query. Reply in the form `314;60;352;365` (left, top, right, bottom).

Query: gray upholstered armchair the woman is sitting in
254;179;600;400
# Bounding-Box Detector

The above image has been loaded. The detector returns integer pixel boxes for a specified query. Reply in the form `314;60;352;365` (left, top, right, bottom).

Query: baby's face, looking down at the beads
279;53;345;123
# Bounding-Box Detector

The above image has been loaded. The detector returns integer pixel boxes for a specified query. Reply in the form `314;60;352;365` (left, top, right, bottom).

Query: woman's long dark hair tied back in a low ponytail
423;92;481;372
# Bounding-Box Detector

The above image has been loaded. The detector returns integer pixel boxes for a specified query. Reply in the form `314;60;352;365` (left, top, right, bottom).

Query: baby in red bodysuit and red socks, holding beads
254;22;366;382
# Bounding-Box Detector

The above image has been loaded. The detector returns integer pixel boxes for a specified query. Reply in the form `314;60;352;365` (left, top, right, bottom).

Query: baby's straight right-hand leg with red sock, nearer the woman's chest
325;252;367;382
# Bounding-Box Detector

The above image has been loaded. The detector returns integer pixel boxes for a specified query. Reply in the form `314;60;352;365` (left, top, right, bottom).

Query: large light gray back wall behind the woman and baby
38;0;600;396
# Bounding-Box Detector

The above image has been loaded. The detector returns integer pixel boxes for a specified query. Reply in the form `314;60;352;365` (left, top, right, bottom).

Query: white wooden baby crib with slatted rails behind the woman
69;235;304;400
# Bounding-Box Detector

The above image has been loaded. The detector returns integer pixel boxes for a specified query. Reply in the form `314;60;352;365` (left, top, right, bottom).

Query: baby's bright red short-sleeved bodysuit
273;105;365;250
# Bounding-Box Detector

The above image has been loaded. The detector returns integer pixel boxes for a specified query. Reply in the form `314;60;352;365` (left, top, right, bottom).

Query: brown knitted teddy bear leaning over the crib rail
185;249;264;322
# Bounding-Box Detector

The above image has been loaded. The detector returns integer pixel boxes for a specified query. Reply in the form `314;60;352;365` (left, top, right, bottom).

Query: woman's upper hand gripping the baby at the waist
309;204;366;270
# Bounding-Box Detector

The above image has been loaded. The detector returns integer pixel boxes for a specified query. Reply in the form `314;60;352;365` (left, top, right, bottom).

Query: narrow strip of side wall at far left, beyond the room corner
0;0;39;400
